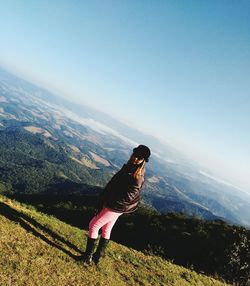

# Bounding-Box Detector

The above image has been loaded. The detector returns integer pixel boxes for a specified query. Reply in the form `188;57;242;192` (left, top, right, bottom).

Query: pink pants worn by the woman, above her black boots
88;208;122;239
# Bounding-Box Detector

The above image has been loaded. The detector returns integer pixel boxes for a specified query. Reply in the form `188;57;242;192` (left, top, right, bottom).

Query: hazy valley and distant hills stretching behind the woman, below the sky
0;65;250;227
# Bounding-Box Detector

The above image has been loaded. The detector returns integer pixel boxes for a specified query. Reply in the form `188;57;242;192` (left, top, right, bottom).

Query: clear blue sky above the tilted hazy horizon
0;0;250;190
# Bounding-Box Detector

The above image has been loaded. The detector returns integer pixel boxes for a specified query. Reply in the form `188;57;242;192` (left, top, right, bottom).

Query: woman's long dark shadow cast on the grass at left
0;202;83;260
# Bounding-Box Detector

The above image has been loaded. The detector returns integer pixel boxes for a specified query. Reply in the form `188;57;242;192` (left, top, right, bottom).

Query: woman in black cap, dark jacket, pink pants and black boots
81;145;151;264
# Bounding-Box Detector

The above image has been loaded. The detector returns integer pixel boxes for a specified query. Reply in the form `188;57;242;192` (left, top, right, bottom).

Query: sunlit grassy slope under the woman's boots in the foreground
0;196;229;286
